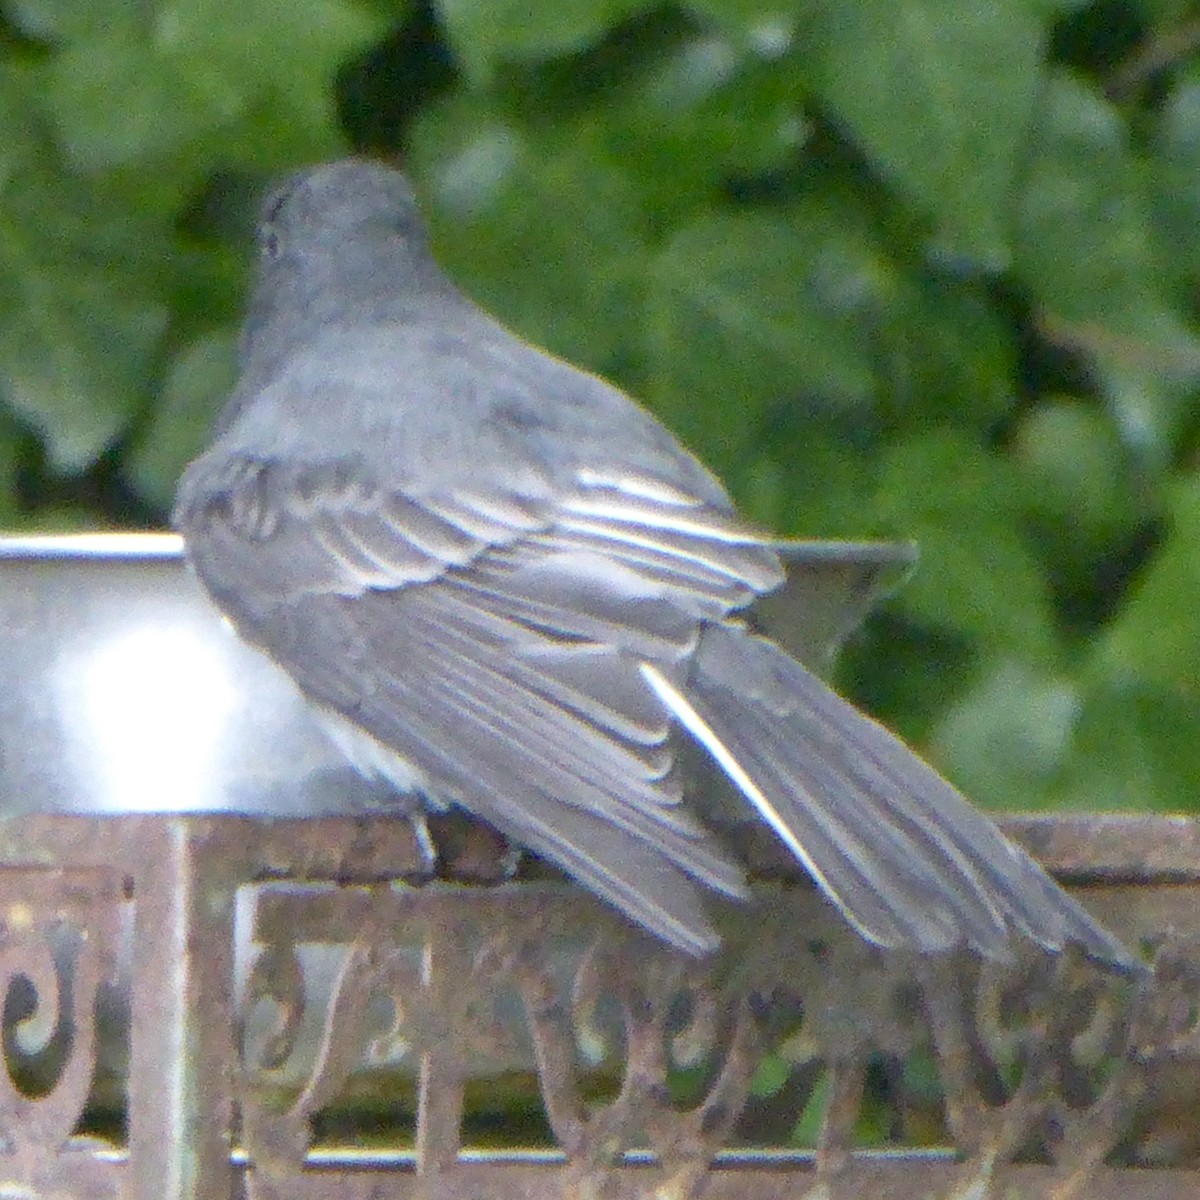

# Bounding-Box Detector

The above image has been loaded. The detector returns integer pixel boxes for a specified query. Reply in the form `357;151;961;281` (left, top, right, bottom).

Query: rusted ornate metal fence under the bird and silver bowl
0;815;1200;1200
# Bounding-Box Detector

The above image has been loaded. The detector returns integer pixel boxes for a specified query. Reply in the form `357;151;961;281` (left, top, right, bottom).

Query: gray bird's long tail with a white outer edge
643;625;1139;971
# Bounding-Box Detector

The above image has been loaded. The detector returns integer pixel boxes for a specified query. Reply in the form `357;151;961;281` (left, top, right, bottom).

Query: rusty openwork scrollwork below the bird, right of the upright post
234;886;1200;1198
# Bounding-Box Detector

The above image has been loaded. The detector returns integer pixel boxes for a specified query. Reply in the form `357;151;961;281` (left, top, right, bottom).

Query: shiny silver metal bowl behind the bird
0;533;912;816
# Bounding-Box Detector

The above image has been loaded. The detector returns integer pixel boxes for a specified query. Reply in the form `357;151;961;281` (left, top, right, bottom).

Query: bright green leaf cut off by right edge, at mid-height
1096;474;1200;704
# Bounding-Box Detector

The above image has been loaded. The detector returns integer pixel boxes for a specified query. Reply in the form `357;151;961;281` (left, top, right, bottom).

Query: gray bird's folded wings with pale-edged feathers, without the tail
178;456;779;952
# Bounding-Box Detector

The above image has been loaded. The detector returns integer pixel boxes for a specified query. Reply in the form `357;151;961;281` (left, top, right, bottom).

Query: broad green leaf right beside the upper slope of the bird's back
646;203;896;460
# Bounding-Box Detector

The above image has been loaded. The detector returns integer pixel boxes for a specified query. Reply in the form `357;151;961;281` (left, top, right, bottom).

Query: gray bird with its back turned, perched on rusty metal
175;161;1135;970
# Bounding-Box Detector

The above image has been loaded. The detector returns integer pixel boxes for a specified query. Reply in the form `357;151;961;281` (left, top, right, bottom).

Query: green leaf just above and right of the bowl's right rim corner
875;431;1057;661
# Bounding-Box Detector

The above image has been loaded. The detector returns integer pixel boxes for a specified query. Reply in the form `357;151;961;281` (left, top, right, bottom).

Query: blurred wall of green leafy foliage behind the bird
0;0;1200;810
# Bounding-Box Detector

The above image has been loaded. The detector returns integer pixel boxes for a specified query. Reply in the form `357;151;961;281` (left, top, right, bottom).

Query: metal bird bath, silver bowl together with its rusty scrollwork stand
0;534;1200;1200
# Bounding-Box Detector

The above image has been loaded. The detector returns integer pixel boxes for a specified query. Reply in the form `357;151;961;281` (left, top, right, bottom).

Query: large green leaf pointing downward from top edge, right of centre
798;0;1044;269
